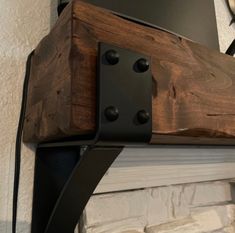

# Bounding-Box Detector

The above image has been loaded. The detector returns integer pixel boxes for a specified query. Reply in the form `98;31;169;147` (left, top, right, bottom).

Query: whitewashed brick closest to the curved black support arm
83;190;147;233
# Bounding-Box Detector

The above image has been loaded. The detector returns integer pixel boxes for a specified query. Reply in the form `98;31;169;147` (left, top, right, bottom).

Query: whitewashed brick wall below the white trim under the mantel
80;181;235;233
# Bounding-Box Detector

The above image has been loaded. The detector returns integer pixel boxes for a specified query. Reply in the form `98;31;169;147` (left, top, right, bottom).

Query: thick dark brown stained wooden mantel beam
24;0;235;144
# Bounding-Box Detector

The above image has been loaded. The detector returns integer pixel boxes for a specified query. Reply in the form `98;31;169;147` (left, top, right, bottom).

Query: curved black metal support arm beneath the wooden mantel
32;147;122;233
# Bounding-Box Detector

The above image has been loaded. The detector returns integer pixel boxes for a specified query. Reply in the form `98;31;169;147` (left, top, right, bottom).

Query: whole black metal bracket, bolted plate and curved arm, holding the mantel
32;43;152;233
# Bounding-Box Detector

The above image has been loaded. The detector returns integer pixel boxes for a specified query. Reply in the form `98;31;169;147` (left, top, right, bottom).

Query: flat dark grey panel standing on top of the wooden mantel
64;0;219;49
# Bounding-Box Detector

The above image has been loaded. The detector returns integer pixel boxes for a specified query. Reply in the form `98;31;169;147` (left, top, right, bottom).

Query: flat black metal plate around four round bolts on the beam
97;43;152;145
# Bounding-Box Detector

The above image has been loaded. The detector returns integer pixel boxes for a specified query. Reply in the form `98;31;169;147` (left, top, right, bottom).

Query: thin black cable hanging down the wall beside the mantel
12;51;34;233
